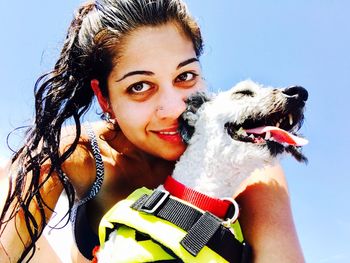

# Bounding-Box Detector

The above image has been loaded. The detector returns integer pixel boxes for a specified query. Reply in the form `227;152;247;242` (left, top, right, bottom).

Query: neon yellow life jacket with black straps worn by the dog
98;188;250;263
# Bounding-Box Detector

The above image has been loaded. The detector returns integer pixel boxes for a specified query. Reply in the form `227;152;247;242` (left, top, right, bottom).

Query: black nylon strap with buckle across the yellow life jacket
131;190;250;263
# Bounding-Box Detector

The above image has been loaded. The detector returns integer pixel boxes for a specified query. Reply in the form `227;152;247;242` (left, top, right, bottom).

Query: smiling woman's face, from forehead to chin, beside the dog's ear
100;23;205;160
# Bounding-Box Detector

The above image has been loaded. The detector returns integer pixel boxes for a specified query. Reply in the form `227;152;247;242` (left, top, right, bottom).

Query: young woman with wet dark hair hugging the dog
0;0;303;262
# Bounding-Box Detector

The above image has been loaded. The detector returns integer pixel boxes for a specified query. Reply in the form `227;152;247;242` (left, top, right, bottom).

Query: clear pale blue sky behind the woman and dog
0;0;350;263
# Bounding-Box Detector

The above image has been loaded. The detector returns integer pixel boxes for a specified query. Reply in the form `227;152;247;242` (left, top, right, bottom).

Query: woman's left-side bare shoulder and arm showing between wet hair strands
0;127;101;262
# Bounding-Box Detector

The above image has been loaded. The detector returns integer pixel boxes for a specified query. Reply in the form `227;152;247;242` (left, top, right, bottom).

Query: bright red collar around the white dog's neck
164;176;232;219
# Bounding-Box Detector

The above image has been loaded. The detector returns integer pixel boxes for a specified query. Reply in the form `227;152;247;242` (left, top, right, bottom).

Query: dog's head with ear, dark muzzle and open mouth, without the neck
180;81;308;162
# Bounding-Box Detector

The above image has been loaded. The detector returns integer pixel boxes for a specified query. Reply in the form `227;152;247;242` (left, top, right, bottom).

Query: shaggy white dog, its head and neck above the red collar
98;81;308;261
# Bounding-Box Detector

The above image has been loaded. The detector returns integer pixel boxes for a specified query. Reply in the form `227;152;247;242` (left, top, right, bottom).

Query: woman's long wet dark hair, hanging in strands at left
0;0;203;261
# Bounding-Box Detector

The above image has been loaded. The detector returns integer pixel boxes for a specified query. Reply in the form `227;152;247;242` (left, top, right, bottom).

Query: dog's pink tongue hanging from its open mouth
245;126;308;146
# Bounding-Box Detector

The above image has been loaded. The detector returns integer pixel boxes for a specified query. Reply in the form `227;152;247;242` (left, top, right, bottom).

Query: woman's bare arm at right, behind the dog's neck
236;166;304;263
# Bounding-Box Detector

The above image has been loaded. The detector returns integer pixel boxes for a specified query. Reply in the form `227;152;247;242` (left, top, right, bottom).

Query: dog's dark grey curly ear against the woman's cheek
179;91;210;143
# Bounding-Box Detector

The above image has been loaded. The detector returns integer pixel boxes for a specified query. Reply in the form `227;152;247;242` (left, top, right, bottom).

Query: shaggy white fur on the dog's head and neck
173;80;307;198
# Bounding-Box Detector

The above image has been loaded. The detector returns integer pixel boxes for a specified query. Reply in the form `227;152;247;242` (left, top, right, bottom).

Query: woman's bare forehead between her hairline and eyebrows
110;23;196;76
